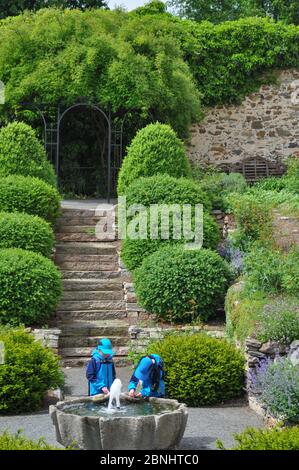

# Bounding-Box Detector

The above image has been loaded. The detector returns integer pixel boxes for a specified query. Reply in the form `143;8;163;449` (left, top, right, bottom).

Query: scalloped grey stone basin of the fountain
49;394;188;450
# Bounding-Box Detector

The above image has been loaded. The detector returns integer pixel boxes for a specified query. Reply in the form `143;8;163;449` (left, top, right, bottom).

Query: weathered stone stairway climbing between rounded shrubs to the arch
54;208;129;366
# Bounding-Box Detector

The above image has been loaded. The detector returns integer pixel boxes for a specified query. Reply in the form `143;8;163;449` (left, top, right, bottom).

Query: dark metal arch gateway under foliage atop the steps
21;101;131;203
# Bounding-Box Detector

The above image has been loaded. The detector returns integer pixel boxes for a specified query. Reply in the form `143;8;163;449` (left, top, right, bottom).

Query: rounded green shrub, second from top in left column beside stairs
0;175;60;223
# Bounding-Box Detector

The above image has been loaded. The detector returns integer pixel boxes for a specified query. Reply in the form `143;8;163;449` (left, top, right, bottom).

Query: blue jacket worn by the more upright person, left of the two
86;348;116;395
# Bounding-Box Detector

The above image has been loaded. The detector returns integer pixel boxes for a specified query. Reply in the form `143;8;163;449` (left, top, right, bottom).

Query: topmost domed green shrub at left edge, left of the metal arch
0;122;57;187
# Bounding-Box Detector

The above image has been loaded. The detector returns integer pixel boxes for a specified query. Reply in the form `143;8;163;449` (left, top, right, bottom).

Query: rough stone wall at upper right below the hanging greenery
188;70;299;171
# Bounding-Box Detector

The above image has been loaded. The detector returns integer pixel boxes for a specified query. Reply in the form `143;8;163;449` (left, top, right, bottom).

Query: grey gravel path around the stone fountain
0;367;263;450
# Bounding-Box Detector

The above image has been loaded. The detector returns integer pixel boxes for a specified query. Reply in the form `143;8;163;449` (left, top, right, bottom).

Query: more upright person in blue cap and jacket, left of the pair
86;338;116;395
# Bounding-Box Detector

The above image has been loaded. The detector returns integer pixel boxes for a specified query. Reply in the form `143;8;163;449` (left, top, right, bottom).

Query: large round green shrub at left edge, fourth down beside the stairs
0;248;62;326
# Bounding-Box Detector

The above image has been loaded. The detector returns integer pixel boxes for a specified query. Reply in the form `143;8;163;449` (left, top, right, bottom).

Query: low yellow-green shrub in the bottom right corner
217;426;299;450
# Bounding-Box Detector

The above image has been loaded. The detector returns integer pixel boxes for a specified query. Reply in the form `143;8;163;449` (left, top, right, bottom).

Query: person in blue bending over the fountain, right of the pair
128;354;165;398
